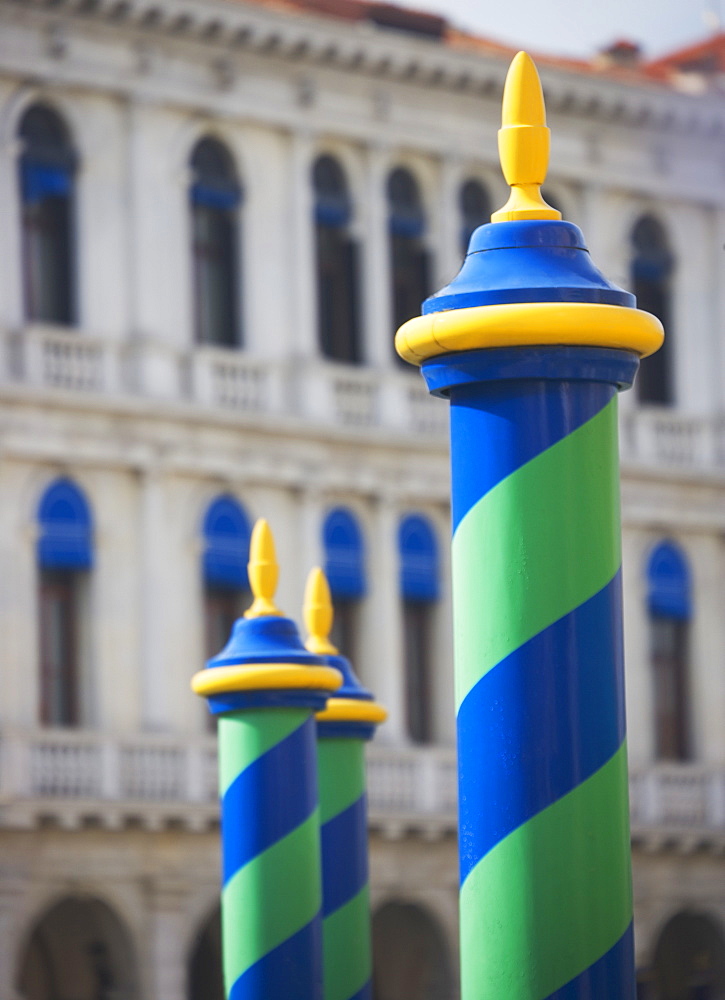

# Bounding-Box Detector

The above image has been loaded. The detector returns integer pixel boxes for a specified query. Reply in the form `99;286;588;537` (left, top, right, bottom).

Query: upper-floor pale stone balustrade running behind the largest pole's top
5;324;725;474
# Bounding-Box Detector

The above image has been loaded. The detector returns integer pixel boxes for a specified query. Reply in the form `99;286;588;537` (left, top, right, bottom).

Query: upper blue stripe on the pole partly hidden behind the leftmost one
320;795;368;917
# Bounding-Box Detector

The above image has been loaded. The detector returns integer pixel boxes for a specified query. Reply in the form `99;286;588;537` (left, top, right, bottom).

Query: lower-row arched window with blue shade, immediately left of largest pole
398;514;439;743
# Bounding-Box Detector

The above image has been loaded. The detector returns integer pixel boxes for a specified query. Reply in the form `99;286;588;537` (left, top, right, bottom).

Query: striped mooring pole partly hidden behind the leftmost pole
304;567;387;1000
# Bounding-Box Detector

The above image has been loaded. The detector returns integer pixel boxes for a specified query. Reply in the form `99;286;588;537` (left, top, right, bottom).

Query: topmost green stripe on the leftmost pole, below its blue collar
219;708;310;796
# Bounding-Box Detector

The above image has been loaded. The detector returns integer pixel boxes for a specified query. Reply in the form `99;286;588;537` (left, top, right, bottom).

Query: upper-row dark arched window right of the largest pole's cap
631;215;675;406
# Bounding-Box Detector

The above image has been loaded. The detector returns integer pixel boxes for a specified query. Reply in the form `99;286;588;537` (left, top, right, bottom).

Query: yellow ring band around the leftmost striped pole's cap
191;663;343;695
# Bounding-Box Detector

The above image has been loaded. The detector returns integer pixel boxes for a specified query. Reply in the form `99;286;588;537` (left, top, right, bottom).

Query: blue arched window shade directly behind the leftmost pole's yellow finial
203;496;250;590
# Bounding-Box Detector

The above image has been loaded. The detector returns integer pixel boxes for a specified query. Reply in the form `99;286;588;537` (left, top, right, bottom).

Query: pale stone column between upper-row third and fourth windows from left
362;146;394;368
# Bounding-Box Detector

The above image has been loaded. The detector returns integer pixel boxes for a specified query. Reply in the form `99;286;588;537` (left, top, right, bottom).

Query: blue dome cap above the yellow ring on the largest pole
423;219;635;316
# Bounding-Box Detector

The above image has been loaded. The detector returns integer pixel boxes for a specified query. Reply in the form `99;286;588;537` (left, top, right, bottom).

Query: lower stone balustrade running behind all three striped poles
0;729;725;843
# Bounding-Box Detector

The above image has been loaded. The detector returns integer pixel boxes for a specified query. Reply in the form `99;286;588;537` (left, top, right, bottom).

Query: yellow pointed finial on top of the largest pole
491;52;561;222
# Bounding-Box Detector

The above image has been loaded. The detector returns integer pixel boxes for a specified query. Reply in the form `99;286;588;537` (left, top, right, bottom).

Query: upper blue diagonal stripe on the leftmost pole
222;716;317;884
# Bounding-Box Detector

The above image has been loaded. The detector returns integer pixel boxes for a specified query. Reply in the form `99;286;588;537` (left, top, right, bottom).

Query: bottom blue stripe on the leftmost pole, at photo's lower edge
228;915;322;1000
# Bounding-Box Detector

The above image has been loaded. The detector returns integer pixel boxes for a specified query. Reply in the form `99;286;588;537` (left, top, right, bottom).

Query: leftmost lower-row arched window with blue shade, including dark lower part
37;479;93;726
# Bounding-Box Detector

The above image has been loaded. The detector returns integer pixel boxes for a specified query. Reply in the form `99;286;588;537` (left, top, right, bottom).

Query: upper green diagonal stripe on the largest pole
453;398;621;707
